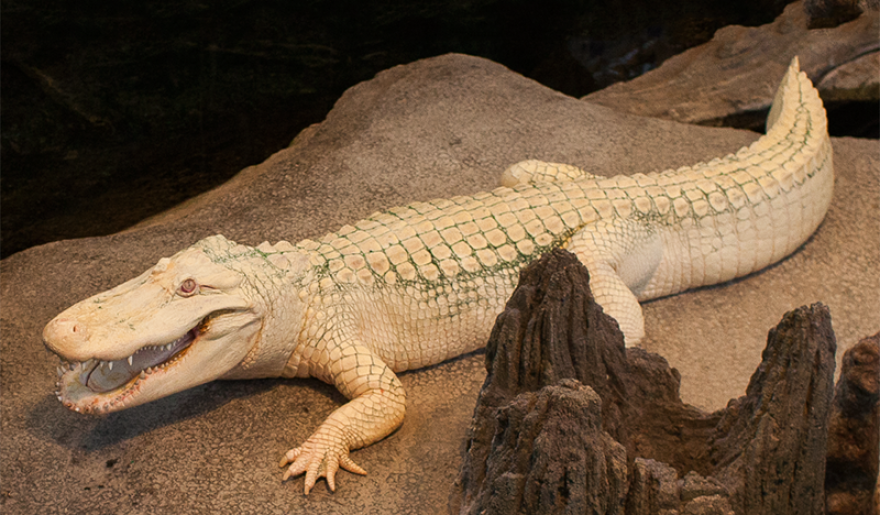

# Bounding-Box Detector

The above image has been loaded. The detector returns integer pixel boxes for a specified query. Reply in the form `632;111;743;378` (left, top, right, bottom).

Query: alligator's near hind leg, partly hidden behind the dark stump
564;220;663;347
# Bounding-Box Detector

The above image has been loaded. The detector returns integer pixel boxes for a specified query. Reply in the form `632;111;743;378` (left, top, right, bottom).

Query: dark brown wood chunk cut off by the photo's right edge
825;333;880;515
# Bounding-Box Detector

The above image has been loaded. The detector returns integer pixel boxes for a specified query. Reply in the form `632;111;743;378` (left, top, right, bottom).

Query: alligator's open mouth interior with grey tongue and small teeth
58;324;201;402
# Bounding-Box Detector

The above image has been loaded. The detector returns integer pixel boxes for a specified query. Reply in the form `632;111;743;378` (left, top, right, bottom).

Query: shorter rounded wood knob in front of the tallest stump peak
465;379;627;515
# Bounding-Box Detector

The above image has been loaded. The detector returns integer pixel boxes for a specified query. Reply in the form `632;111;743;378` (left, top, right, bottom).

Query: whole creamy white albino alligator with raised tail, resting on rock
43;59;834;494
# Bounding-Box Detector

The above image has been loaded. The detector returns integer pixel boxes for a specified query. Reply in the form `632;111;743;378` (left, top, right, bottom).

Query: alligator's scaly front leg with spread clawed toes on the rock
280;343;406;495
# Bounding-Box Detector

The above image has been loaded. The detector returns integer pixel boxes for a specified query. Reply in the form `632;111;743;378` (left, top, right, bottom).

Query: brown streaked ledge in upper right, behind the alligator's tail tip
584;2;880;130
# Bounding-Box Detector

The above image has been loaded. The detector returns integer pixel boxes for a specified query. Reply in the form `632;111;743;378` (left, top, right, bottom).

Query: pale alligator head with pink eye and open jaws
43;236;278;413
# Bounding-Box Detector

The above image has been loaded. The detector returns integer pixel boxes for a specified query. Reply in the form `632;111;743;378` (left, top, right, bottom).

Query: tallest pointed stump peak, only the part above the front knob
481;250;627;425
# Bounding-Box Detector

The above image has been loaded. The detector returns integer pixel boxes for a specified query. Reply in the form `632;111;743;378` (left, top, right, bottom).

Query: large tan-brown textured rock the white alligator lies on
0;55;880;514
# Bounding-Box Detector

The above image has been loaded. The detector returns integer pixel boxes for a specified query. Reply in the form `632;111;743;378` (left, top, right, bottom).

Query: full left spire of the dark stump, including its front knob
451;247;627;514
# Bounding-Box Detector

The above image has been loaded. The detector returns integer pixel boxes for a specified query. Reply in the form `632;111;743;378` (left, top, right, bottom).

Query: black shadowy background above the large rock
0;0;824;258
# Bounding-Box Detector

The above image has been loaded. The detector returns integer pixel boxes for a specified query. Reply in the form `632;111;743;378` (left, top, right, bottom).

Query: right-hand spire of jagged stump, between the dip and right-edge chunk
711;304;836;515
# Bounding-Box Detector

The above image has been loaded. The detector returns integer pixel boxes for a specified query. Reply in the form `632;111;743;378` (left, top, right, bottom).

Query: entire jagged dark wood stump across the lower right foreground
450;250;880;515
